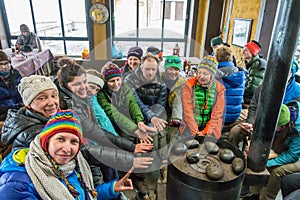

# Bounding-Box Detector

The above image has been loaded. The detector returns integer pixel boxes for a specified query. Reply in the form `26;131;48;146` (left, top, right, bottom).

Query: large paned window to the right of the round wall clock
112;0;191;56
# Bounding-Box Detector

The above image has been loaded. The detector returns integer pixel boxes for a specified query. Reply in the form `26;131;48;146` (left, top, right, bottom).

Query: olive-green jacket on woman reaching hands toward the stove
97;82;144;136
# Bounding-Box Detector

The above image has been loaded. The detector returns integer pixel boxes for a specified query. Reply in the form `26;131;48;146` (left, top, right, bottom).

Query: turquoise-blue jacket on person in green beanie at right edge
267;101;300;167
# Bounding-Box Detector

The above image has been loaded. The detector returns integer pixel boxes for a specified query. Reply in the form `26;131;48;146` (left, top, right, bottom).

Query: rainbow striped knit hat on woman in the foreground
40;110;82;152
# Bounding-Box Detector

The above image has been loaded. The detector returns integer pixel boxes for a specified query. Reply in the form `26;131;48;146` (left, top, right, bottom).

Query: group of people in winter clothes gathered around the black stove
0;33;300;199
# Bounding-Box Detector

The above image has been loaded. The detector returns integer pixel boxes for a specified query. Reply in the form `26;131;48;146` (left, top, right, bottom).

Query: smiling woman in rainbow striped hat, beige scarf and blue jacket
0;110;132;200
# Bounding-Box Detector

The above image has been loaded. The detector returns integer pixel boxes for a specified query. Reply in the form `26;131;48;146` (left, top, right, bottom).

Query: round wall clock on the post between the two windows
89;3;109;24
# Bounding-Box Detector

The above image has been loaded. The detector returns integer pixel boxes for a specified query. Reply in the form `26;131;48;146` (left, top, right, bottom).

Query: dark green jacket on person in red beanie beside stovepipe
244;56;266;104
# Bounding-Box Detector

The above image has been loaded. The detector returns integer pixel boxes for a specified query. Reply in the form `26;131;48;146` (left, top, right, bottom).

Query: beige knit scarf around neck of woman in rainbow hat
25;135;96;200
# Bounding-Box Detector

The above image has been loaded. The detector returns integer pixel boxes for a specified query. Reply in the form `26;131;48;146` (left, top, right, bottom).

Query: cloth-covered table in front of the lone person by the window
5;49;54;77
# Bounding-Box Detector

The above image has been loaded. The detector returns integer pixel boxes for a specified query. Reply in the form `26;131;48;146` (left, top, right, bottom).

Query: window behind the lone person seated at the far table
1;0;89;57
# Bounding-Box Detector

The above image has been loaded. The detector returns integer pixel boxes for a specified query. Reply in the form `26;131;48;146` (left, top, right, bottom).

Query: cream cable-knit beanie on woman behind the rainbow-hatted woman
18;75;58;106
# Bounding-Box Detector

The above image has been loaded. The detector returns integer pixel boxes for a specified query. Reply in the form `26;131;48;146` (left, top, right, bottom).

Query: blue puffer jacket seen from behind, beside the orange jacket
218;62;246;123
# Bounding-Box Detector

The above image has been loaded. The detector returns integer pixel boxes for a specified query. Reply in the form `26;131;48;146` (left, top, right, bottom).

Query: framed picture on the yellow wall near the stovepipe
232;18;252;47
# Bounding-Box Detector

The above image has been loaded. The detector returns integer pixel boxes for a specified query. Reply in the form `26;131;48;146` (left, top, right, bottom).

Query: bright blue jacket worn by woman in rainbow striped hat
0;150;120;200
